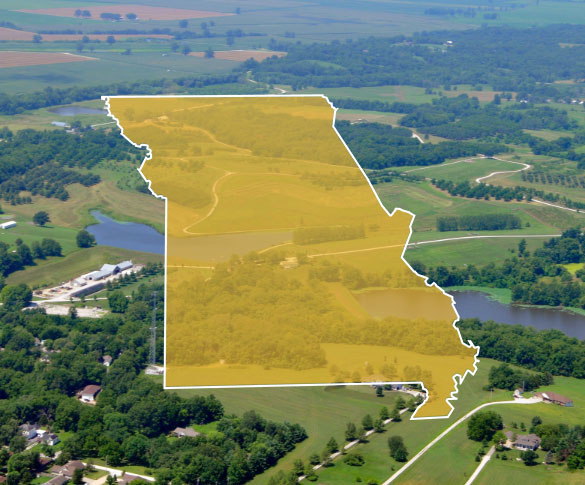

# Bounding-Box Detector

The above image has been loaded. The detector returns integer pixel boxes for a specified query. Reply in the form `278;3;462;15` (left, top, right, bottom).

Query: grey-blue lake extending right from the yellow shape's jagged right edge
449;291;585;340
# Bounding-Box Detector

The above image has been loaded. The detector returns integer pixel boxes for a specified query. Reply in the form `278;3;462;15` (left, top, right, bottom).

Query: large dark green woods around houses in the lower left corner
0;285;307;485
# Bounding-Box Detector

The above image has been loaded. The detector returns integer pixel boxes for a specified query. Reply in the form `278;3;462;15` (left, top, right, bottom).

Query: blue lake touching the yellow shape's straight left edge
86;211;165;254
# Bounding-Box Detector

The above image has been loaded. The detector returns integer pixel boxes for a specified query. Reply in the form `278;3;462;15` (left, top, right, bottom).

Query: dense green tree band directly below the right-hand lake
457;319;585;379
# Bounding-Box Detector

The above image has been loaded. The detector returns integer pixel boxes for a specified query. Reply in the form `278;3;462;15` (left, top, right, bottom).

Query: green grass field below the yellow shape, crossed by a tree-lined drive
164;359;510;484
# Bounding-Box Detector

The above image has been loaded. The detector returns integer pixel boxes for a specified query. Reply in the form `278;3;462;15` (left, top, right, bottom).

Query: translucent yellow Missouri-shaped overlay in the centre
107;96;478;418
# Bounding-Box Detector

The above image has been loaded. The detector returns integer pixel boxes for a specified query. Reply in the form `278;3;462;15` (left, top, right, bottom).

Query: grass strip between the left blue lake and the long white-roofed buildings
6;246;162;288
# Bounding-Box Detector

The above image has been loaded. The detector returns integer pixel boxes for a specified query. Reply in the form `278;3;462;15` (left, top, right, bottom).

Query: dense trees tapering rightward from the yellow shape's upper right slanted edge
335;121;510;169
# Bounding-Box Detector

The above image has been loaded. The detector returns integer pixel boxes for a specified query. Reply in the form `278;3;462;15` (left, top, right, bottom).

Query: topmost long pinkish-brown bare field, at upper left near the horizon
19;5;233;20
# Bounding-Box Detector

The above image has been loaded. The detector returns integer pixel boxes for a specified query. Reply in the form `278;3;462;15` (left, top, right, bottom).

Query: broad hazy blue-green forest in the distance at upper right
249;25;585;100
